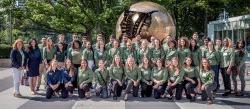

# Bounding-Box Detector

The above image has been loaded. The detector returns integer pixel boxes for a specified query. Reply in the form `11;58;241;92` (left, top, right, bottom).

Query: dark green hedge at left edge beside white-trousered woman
0;44;12;59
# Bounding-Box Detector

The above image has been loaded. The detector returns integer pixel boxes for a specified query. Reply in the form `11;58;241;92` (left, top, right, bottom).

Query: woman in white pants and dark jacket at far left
10;39;27;98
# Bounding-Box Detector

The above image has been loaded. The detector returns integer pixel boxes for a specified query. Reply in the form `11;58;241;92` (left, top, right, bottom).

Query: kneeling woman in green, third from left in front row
77;59;93;98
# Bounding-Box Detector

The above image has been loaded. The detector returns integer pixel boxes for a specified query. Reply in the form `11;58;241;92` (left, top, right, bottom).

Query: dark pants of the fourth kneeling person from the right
154;83;167;99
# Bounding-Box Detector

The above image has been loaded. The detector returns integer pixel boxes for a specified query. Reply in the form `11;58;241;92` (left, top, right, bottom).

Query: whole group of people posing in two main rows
10;32;247;104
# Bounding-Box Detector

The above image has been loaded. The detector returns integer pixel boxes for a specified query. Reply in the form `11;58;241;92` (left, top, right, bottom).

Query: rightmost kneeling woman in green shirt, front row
199;58;216;104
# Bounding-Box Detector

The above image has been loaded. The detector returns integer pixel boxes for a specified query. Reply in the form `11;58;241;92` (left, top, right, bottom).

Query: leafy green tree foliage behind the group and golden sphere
0;0;250;43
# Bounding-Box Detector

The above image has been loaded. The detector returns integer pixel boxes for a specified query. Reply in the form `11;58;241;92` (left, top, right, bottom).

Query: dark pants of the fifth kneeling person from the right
140;81;153;97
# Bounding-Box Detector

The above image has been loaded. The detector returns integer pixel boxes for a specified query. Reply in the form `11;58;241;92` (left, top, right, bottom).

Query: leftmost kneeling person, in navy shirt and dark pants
46;60;68;99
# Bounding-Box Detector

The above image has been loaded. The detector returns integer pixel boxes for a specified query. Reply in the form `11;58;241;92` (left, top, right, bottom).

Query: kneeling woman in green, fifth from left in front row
109;55;125;100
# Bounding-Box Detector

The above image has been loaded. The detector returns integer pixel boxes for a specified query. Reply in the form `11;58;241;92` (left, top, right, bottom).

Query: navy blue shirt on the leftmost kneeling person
47;69;63;85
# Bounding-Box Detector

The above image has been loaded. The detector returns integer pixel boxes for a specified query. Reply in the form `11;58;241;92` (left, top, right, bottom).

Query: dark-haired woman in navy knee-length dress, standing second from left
27;39;42;95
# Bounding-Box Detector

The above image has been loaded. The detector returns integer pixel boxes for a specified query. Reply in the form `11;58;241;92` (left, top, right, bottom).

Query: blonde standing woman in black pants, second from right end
220;38;235;96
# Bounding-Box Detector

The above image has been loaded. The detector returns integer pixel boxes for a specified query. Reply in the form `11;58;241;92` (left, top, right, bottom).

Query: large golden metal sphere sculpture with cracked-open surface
116;2;175;41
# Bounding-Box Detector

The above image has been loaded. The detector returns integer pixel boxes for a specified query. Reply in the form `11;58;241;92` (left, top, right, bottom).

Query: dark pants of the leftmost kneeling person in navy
46;84;68;99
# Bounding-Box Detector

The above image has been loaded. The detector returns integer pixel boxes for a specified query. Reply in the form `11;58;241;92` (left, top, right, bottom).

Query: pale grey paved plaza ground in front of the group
0;69;250;109
